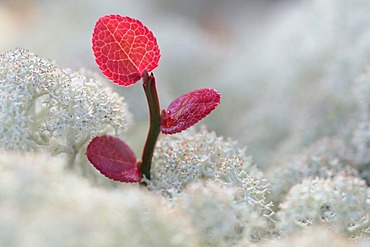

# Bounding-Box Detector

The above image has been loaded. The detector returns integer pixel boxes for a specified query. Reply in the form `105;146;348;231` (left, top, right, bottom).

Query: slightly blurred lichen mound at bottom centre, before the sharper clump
174;180;275;247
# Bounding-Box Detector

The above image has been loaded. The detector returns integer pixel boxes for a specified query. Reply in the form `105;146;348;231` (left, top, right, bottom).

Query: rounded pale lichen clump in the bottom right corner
277;174;370;238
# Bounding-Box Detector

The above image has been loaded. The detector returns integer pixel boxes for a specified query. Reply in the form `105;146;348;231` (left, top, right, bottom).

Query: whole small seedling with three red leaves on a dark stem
86;15;221;183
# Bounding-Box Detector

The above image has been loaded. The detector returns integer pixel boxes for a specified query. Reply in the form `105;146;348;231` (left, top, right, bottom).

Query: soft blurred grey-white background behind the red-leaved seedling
0;0;370;168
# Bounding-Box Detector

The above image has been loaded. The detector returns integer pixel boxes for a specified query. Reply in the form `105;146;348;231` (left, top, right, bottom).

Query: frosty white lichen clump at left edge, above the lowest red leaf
0;49;130;169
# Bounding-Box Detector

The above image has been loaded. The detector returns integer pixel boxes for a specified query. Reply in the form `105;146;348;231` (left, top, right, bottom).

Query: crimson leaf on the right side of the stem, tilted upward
161;88;221;134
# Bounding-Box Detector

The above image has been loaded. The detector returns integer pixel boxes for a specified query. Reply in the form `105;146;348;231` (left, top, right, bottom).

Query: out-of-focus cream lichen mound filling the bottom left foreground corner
0;152;199;247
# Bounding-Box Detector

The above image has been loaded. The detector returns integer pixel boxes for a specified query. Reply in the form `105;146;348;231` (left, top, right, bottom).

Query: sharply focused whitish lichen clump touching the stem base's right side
148;126;268;197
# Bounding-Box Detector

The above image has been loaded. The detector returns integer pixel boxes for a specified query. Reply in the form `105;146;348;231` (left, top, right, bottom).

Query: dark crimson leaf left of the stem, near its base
86;135;142;183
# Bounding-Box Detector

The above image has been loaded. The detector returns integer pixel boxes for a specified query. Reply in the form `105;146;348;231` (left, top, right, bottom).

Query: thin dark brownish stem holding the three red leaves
140;71;161;179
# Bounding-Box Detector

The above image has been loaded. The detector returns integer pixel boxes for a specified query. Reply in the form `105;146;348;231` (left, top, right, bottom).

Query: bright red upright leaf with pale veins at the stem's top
92;15;161;86
